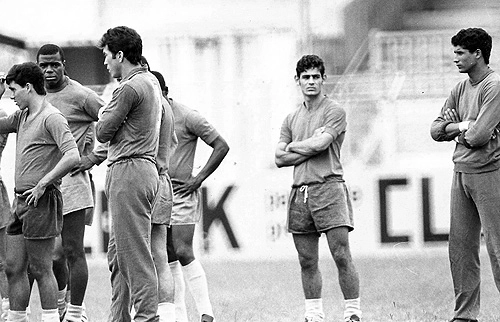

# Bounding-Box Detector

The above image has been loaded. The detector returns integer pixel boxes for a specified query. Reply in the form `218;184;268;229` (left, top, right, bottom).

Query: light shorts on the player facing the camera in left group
61;171;94;215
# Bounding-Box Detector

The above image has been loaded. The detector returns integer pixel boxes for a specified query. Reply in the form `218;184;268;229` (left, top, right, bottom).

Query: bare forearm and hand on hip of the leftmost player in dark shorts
23;147;80;207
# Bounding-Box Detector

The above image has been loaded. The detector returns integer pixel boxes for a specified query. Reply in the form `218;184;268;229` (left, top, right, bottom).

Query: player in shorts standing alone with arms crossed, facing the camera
275;55;361;322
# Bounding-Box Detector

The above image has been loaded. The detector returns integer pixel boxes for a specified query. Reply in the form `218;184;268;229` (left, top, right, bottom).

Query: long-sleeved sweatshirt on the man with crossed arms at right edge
431;70;500;173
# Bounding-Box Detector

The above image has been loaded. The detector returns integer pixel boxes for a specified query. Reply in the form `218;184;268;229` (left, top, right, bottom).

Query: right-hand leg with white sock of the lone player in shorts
326;226;361;321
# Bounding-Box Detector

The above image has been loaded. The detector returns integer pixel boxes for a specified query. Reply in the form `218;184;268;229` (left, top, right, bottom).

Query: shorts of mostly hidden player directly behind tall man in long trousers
151;174;173;225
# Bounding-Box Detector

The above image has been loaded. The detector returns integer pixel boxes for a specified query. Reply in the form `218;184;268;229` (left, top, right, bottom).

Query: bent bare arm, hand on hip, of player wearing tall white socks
175;135;229;195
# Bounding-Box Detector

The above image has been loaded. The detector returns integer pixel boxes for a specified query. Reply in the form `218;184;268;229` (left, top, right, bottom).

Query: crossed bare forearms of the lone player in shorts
274;127;334;168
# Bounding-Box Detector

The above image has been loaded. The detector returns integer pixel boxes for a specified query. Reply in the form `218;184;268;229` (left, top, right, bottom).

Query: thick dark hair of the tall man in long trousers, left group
97;26;142;65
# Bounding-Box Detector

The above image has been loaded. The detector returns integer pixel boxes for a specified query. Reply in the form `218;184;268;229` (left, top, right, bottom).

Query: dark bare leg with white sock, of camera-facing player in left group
61;209;88;321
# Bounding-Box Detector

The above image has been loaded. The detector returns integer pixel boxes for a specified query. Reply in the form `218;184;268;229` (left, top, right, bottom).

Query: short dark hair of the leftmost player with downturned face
5;62;46;95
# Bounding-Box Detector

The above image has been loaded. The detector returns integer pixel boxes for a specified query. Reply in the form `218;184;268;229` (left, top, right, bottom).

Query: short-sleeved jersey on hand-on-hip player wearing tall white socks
169;99;219;182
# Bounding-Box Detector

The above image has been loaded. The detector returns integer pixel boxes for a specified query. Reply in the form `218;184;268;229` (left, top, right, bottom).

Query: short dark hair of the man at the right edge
451;28;492;64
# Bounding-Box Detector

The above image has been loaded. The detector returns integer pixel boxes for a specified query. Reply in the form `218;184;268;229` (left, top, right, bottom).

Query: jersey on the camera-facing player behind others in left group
47;76;104;155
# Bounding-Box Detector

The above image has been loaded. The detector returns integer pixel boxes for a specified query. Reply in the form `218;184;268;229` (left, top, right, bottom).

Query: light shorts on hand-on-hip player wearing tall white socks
170;190;201;225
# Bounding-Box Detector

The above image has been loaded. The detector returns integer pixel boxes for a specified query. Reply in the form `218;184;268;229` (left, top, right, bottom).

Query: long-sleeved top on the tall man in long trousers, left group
95;66;162;165
